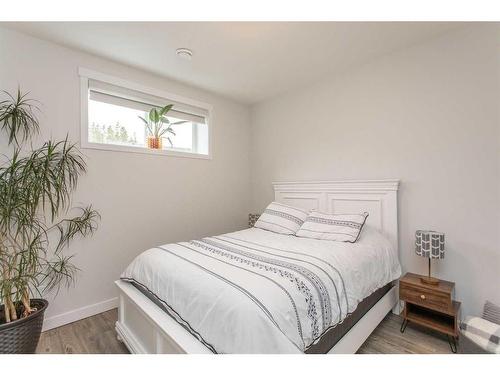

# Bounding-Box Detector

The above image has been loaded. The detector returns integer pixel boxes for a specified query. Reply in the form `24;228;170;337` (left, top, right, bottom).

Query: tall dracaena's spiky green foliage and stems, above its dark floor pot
0;89;100;323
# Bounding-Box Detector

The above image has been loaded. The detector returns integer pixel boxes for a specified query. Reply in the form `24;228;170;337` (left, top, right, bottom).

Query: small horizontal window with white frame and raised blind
80;69;210;158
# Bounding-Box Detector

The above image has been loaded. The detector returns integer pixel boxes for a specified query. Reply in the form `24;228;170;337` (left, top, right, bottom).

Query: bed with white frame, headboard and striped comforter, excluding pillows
116;180;401;353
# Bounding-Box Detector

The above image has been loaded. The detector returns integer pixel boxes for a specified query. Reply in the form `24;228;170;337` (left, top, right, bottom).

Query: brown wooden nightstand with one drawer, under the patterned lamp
399;273;460;353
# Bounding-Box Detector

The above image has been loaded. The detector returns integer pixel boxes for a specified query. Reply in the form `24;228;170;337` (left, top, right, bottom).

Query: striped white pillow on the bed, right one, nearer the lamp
297;211;368;243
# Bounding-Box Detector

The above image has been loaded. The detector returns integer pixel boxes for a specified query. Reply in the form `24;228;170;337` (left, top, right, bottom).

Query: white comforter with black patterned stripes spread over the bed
122;227;401;353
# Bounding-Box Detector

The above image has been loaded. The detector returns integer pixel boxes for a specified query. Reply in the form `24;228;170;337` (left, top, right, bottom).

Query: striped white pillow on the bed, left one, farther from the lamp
254;202;307;234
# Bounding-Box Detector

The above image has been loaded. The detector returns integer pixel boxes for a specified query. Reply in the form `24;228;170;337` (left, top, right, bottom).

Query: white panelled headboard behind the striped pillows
273;180;399;254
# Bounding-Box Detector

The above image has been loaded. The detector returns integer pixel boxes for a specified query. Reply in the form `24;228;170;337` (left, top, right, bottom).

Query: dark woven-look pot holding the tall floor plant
0;299;49;354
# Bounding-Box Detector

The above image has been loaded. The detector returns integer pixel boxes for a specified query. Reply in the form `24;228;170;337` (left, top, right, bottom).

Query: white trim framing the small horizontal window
78;67;213;160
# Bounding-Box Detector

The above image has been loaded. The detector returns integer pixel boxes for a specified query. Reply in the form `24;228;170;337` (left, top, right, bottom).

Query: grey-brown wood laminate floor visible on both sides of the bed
37;309;450;354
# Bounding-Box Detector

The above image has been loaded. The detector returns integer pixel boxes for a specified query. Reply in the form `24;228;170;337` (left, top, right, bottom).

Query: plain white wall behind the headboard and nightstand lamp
251;25;500;314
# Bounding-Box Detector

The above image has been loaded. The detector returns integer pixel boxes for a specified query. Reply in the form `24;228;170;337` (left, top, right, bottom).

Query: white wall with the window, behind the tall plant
0;28;250;324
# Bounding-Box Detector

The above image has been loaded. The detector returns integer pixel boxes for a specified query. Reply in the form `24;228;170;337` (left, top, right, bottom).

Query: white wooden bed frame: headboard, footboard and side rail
116;180;400;354
